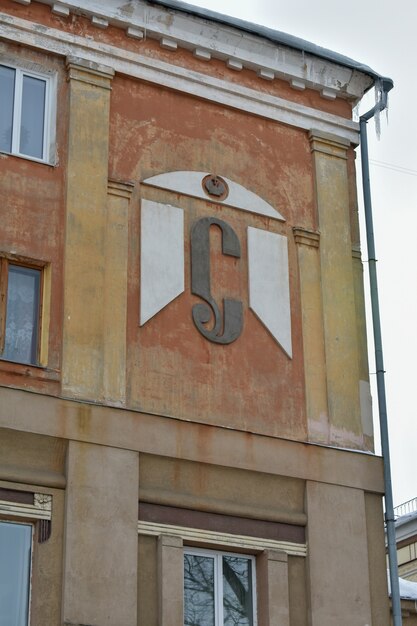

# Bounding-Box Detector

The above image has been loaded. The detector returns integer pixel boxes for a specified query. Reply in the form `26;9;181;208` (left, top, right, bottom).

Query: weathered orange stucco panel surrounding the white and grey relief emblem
110;77;316;438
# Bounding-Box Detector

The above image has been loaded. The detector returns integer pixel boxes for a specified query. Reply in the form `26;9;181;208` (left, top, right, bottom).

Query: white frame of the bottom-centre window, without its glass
184;546;258;626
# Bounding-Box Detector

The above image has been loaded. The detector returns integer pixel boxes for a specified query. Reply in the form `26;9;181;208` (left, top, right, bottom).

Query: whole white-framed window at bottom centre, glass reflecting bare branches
184;548;256;626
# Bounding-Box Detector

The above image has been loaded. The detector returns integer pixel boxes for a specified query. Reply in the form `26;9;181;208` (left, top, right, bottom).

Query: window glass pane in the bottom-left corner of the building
0;522;32;626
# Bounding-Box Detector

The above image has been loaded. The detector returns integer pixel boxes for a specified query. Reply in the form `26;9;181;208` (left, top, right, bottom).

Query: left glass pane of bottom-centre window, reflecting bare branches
184;554;215;626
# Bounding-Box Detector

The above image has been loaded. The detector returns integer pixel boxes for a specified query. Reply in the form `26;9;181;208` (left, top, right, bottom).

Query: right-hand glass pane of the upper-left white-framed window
19;76;46;159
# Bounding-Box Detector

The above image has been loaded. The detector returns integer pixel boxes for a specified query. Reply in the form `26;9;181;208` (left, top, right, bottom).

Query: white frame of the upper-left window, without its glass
0;59;56;165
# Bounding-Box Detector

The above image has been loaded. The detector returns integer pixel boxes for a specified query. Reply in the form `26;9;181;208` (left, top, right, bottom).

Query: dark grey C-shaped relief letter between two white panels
191;217;243;344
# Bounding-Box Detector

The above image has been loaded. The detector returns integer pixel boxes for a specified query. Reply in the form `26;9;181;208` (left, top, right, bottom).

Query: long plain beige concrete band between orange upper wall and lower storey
0;387;384;494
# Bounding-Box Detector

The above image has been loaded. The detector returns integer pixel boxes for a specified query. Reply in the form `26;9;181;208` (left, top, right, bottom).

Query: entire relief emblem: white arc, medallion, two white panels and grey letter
140;171;292;358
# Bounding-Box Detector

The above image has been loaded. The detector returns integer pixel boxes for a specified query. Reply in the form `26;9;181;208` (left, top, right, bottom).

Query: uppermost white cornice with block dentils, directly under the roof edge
15;0;373;101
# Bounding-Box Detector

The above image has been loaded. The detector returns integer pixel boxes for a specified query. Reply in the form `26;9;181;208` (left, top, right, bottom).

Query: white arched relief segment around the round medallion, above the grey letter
142;171;285;222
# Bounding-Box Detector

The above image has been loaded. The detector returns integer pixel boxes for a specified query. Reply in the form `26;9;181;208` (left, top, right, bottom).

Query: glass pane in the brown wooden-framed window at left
3;265;41;363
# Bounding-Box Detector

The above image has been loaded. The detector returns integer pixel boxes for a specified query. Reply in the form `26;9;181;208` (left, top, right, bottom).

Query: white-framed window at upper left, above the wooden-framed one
0;64;52;162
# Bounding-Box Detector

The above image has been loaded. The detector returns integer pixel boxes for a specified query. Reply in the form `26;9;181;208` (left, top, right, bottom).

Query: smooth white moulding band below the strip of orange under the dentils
0;13;359;144
